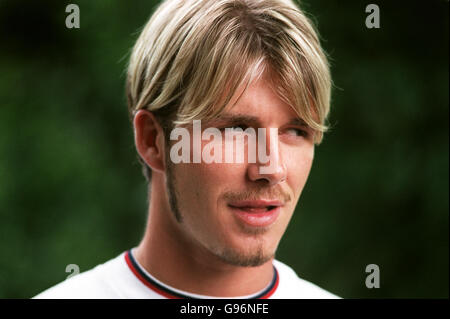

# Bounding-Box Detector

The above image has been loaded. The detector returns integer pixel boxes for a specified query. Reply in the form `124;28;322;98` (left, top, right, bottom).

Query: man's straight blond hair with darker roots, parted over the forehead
126;0;331;177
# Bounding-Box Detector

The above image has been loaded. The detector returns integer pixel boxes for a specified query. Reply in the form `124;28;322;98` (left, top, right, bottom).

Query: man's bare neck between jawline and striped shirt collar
135;174;273;297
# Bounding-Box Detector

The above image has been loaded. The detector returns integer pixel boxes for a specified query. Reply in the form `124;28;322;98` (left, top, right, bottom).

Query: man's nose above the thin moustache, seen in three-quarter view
248;129;287;186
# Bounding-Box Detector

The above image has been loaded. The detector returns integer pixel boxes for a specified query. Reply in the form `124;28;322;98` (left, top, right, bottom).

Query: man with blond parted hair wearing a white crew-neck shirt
37;0;336;298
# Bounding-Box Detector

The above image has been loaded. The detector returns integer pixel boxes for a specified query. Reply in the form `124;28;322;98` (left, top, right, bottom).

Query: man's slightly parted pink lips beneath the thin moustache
228;200;283;227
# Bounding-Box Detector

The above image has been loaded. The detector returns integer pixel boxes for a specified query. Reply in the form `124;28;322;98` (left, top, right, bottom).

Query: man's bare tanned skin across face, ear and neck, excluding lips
134;73;314;297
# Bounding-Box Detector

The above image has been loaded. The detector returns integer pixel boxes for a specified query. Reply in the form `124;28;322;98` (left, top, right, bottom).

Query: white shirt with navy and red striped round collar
34;250;339;299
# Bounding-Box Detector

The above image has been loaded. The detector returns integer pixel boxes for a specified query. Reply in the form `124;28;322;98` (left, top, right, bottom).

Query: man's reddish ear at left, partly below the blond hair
133;110;165;172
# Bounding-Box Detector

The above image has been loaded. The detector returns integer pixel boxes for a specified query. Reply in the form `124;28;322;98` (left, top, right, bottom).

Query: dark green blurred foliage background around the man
0;0;449;298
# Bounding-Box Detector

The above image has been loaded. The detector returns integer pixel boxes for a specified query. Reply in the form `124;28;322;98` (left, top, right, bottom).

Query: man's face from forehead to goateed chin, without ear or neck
163;78;314;266
